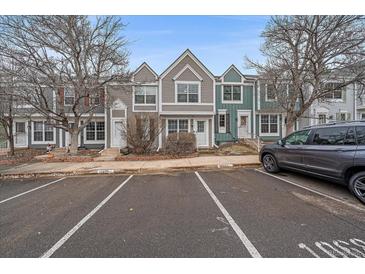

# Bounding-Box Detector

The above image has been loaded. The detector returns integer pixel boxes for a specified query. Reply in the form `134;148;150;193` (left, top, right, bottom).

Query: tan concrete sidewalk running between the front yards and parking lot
0;155;260;178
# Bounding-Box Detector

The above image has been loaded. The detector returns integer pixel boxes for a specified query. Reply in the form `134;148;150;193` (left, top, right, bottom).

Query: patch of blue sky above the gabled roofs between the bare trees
122;15;268;75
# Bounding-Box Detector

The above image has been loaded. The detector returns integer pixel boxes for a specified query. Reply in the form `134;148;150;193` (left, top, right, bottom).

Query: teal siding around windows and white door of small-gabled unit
215;84;253;144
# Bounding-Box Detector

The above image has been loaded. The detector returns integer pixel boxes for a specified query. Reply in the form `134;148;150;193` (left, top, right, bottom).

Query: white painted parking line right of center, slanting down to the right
195;171;261;258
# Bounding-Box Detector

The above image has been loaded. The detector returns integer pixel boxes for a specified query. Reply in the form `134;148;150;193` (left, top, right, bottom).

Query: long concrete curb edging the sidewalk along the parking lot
0;163;260;179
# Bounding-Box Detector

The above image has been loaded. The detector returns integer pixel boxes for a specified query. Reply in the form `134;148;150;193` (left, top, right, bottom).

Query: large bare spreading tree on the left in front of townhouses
0;16;129;153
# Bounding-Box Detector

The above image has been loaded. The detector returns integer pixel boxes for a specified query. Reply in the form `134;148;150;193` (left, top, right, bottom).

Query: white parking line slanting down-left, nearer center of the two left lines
41;175;133;258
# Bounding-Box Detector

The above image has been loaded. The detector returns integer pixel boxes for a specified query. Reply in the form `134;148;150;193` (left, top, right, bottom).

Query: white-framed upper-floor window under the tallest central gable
175;81;201;104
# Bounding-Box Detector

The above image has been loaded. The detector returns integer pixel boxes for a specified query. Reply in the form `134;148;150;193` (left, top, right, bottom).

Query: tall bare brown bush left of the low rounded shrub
121;113;163;154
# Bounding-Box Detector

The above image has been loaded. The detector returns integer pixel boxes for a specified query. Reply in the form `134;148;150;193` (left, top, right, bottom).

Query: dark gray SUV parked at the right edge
260;121;365;204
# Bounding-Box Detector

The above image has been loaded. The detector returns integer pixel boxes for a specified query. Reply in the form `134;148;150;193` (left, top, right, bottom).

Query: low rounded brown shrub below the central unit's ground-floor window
164;132;196;155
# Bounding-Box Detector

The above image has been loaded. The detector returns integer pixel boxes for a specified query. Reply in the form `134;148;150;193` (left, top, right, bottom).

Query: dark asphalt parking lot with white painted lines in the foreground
0;168;365;258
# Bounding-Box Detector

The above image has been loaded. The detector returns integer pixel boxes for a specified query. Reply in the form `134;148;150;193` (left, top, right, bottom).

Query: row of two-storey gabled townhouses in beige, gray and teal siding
9;49;365;150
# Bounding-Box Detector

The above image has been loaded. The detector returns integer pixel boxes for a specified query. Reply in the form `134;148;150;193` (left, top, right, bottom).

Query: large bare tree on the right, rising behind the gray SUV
246;16;365;133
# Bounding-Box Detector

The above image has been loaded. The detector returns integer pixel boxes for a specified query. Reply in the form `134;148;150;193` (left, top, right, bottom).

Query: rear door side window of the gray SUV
313;127;348;145
